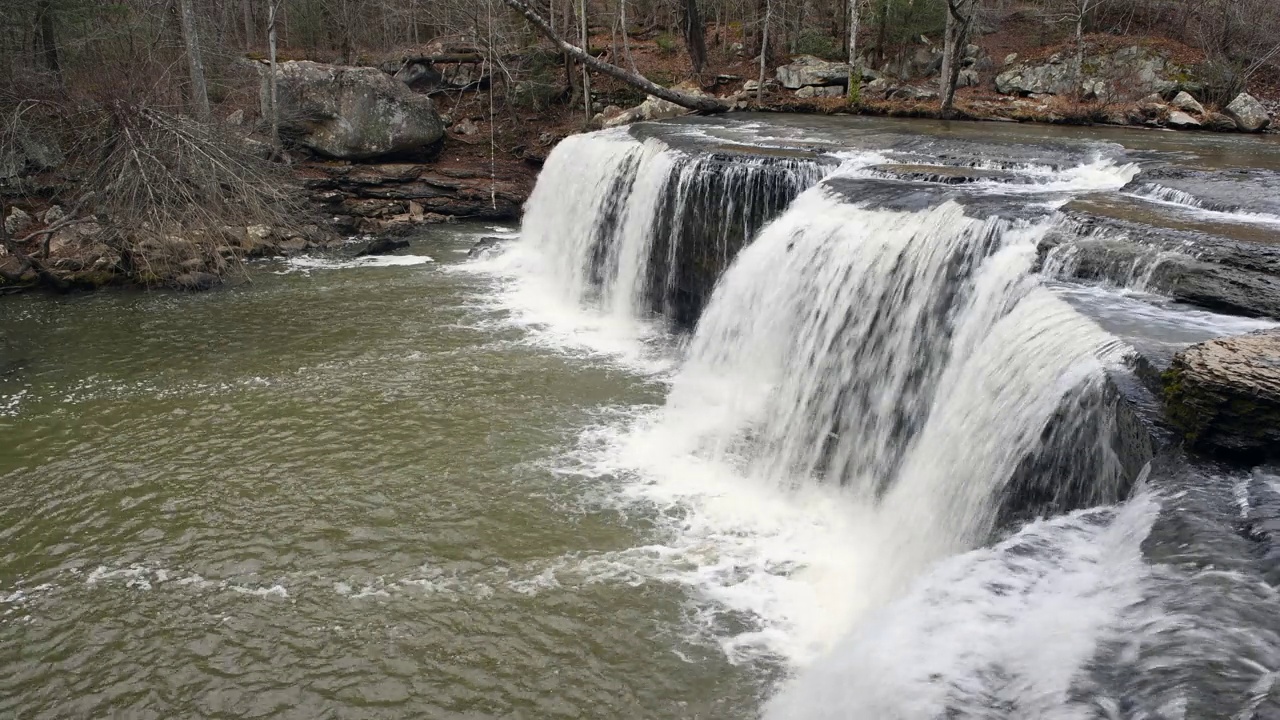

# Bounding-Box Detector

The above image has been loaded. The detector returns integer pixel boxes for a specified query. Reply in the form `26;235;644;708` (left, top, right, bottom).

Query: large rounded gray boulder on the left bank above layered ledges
262;61;444;160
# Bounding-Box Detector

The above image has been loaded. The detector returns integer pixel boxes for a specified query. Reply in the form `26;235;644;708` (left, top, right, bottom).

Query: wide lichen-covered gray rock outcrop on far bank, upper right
996;46;1181;100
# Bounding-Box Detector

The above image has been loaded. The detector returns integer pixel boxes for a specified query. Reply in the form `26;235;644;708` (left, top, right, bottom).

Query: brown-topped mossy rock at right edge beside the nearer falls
1164;331;1280;462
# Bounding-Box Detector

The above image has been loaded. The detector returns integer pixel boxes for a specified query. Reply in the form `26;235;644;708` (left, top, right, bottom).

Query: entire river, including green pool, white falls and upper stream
0;118;1280;720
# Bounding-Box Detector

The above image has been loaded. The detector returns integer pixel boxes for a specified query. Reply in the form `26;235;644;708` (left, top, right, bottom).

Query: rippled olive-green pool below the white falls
0;228;773;719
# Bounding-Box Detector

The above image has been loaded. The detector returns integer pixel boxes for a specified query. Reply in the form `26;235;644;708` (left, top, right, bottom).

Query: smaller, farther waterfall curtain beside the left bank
522;129;835;325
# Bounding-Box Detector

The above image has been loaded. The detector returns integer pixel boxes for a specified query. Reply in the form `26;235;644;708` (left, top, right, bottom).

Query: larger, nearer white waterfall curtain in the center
623;188;1131;652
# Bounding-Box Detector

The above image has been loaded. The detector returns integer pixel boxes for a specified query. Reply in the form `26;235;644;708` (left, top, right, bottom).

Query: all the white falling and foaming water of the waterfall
486;119;1280;720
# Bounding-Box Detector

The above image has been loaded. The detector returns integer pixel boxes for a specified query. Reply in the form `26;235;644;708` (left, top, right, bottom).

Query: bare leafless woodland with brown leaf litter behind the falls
0;0;1280;284
